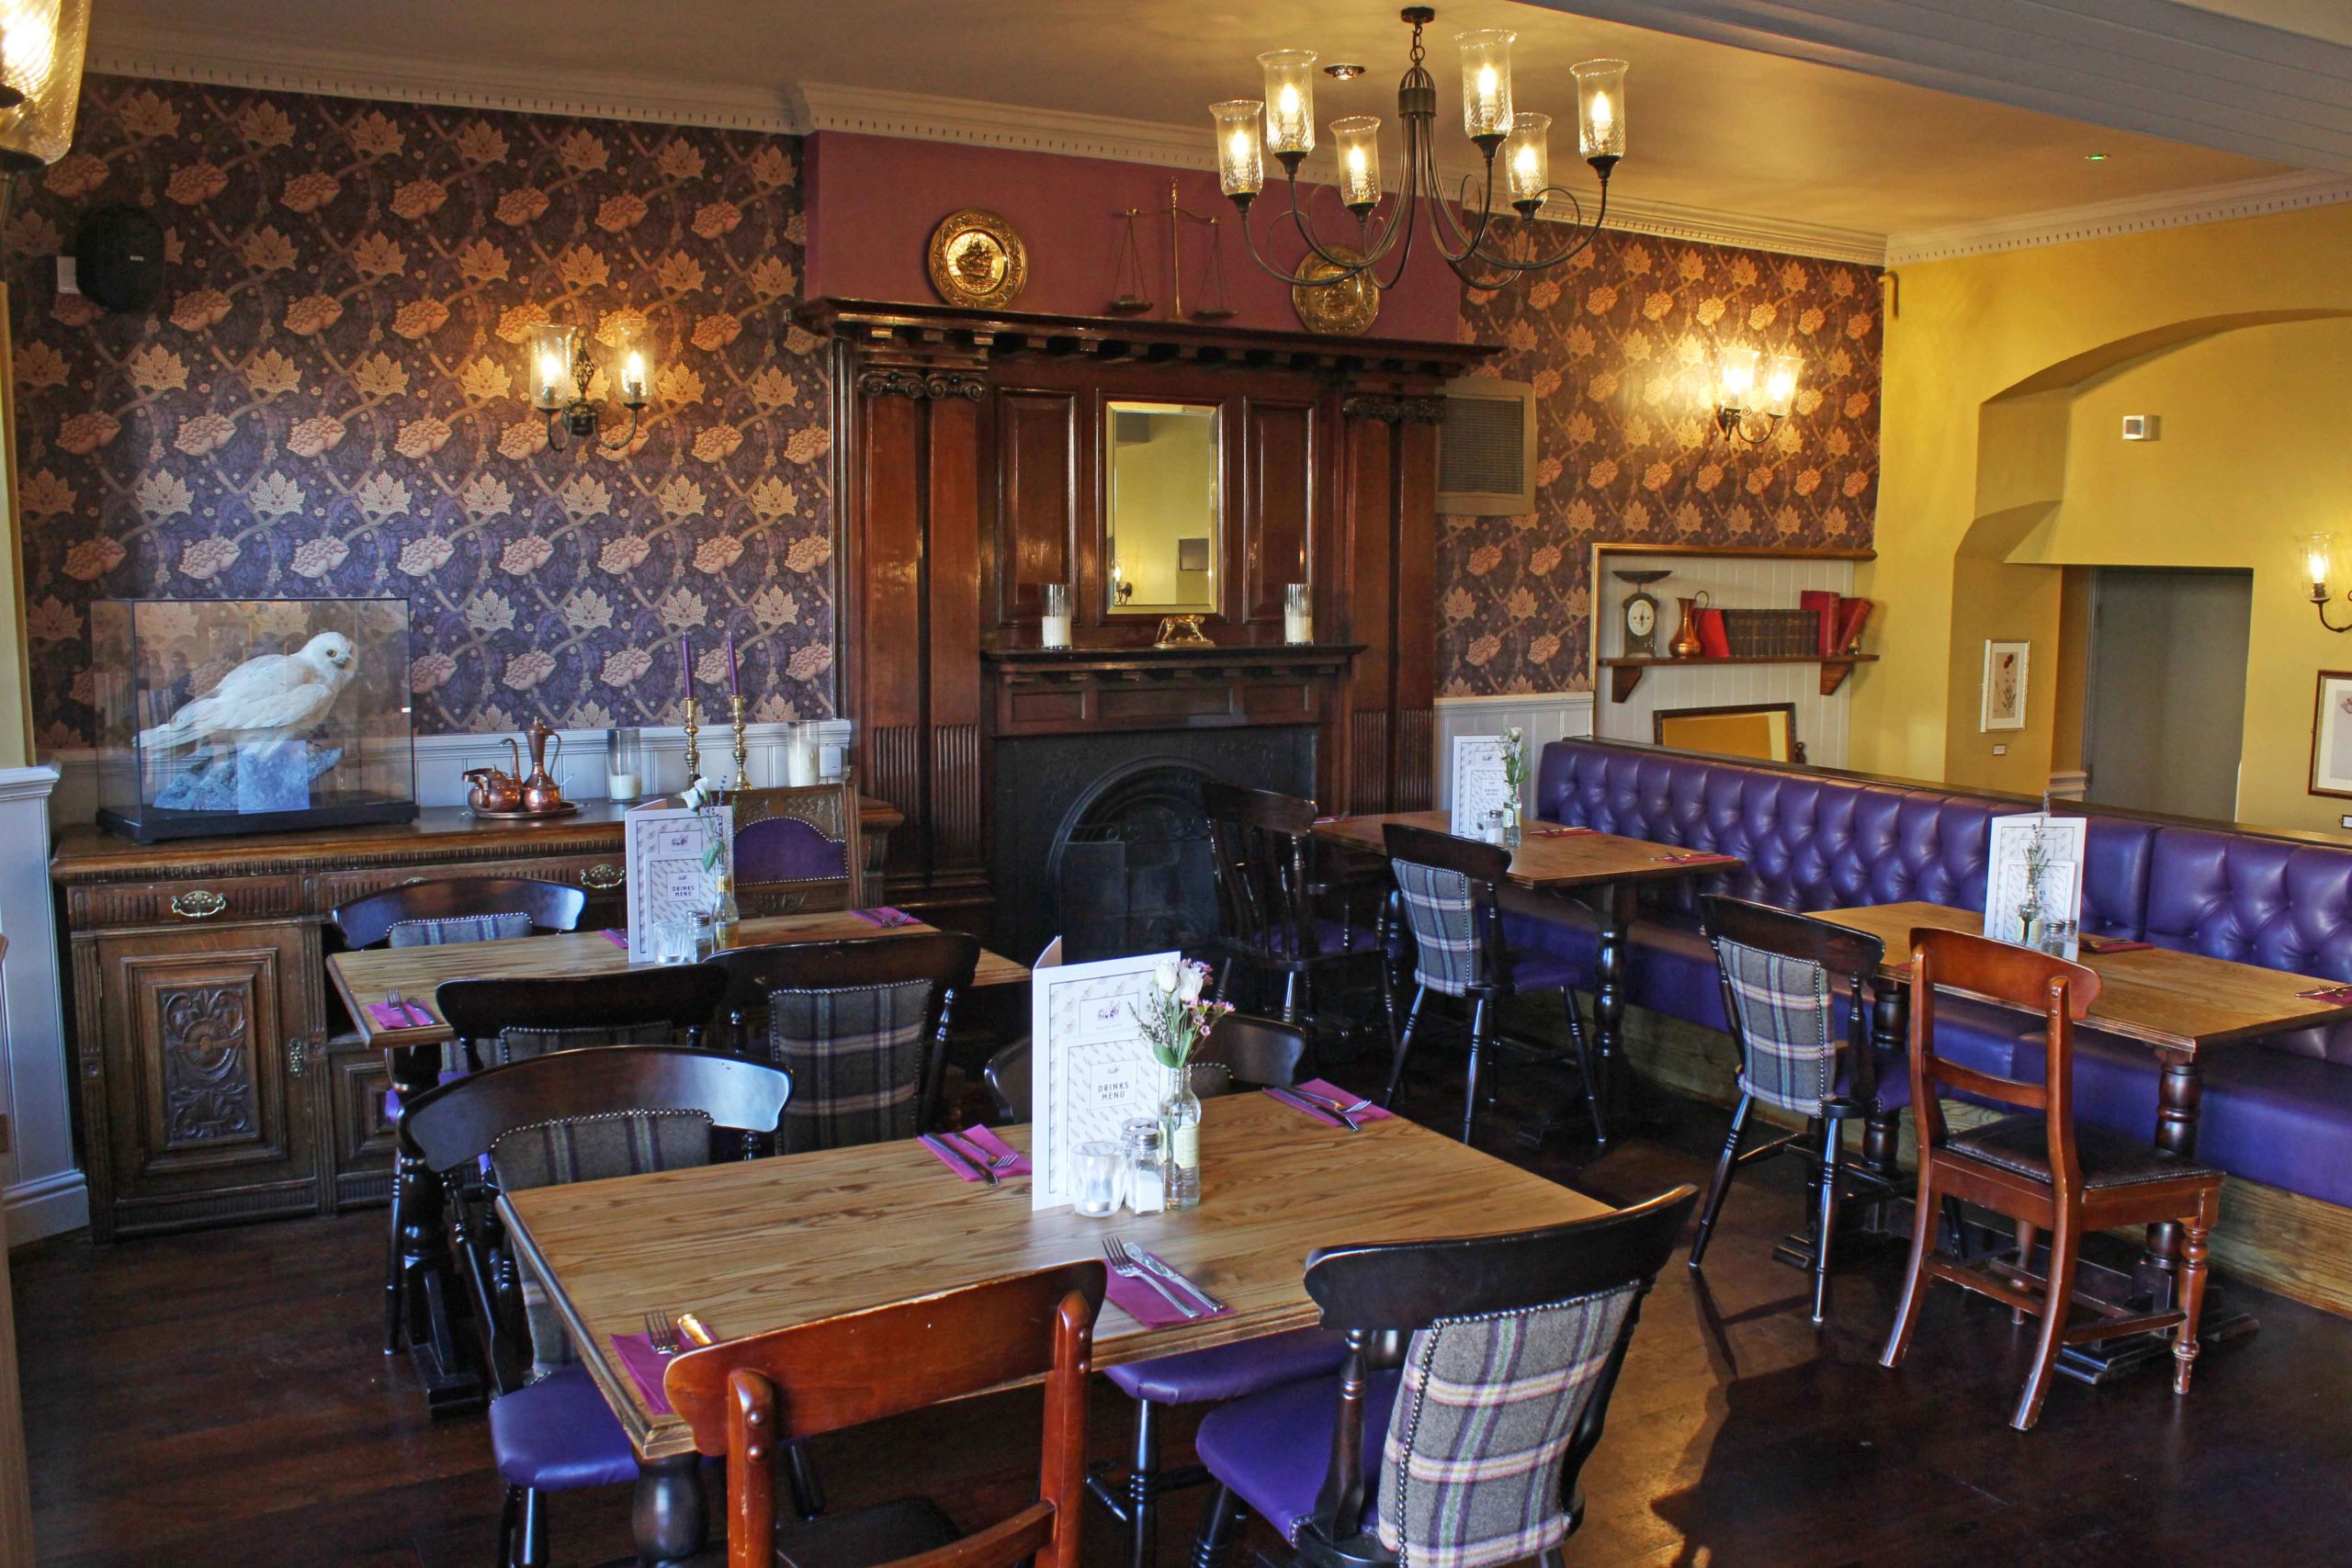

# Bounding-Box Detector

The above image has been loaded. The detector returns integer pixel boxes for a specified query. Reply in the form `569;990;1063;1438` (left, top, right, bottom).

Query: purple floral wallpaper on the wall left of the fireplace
7;77;832;745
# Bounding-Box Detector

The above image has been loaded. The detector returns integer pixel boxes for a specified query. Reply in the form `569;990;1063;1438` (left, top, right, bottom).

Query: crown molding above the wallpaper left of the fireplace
87;18;807;134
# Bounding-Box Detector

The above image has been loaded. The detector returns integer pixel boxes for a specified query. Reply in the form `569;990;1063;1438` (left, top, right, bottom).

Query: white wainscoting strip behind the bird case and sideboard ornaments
47;719;852;823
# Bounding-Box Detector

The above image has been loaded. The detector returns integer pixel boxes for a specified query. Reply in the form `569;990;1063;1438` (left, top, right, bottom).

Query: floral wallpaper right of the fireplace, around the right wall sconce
1437;232;1879;696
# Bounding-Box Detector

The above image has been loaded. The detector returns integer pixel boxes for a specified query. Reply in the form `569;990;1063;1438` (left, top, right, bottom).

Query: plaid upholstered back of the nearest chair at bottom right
1378;1283;1639;1568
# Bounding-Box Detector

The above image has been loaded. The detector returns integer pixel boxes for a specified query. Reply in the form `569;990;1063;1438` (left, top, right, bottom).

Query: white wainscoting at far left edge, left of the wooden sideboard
0;766;89;1244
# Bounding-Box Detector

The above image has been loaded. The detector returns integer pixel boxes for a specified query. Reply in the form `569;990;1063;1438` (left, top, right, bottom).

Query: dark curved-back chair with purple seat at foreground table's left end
400;1046;793;1568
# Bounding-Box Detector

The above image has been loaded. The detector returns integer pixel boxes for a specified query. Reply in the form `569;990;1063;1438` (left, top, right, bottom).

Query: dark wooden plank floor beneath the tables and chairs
14;1063;2352;1568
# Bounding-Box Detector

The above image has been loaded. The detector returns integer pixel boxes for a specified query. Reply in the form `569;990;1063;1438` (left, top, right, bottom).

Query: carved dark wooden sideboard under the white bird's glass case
50;799;900;1241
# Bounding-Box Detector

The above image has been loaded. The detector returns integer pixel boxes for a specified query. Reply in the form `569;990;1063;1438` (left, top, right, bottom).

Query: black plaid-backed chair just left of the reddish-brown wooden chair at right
1689;894;1907;1324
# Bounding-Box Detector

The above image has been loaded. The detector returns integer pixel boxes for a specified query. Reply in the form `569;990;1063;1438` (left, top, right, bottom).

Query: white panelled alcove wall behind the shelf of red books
1592;550;1870;769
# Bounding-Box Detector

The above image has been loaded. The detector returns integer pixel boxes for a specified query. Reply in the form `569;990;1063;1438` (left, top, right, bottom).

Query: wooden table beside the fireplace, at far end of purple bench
1315;811;1743;1145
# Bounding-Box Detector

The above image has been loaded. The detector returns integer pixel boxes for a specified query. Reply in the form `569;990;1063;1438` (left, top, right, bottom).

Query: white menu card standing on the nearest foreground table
1030;952;1179;1208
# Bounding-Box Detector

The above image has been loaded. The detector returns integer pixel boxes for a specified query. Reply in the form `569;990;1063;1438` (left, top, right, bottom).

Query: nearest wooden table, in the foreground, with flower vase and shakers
499;1093;1609;1561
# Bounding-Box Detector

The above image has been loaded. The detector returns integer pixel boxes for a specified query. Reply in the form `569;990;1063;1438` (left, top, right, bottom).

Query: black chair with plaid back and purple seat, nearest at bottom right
1193;1185;1698;1568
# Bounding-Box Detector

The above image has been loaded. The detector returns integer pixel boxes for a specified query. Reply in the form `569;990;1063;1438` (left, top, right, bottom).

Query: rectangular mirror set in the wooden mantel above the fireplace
1103;402;1223;616
